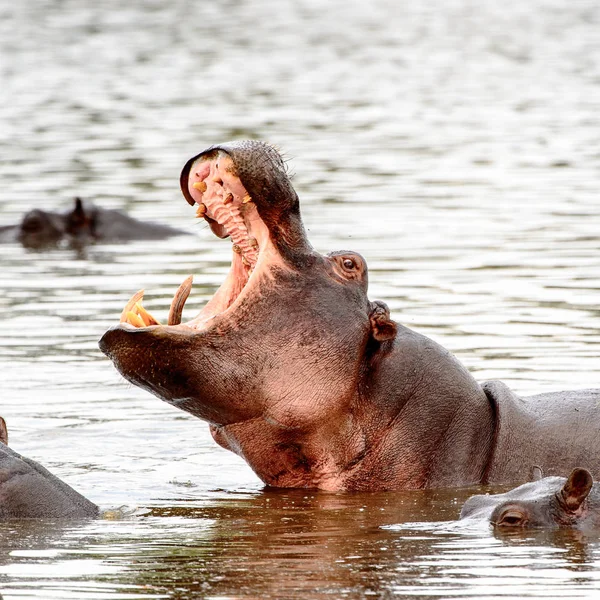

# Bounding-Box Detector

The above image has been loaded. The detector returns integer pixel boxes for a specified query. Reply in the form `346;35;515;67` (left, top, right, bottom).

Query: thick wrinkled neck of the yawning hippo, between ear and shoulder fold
352;326;495;489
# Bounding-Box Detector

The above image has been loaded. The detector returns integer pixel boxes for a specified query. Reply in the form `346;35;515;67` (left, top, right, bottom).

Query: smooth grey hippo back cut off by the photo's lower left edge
0;417;99;520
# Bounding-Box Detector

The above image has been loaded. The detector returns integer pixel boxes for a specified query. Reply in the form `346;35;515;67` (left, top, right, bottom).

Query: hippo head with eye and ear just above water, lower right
460;468;600;529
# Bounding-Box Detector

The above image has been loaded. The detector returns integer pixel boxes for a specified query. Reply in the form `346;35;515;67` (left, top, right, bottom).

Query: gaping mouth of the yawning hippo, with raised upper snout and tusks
116;141;310;330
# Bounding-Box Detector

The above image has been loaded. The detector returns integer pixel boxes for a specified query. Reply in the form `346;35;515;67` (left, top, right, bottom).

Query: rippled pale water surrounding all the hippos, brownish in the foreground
0;0;600;600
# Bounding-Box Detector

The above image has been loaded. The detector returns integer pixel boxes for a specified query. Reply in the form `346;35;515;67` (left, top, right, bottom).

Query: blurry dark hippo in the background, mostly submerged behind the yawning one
0;198;187;248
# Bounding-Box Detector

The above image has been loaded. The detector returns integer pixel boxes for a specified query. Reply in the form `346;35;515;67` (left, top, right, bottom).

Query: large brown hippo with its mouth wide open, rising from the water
100;141;600;490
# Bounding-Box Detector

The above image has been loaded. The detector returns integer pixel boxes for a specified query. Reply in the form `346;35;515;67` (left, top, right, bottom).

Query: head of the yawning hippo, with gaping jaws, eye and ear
100;142;418;489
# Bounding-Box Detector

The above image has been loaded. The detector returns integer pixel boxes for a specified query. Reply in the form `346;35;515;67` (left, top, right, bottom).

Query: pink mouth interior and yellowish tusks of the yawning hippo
114;142;298;330
